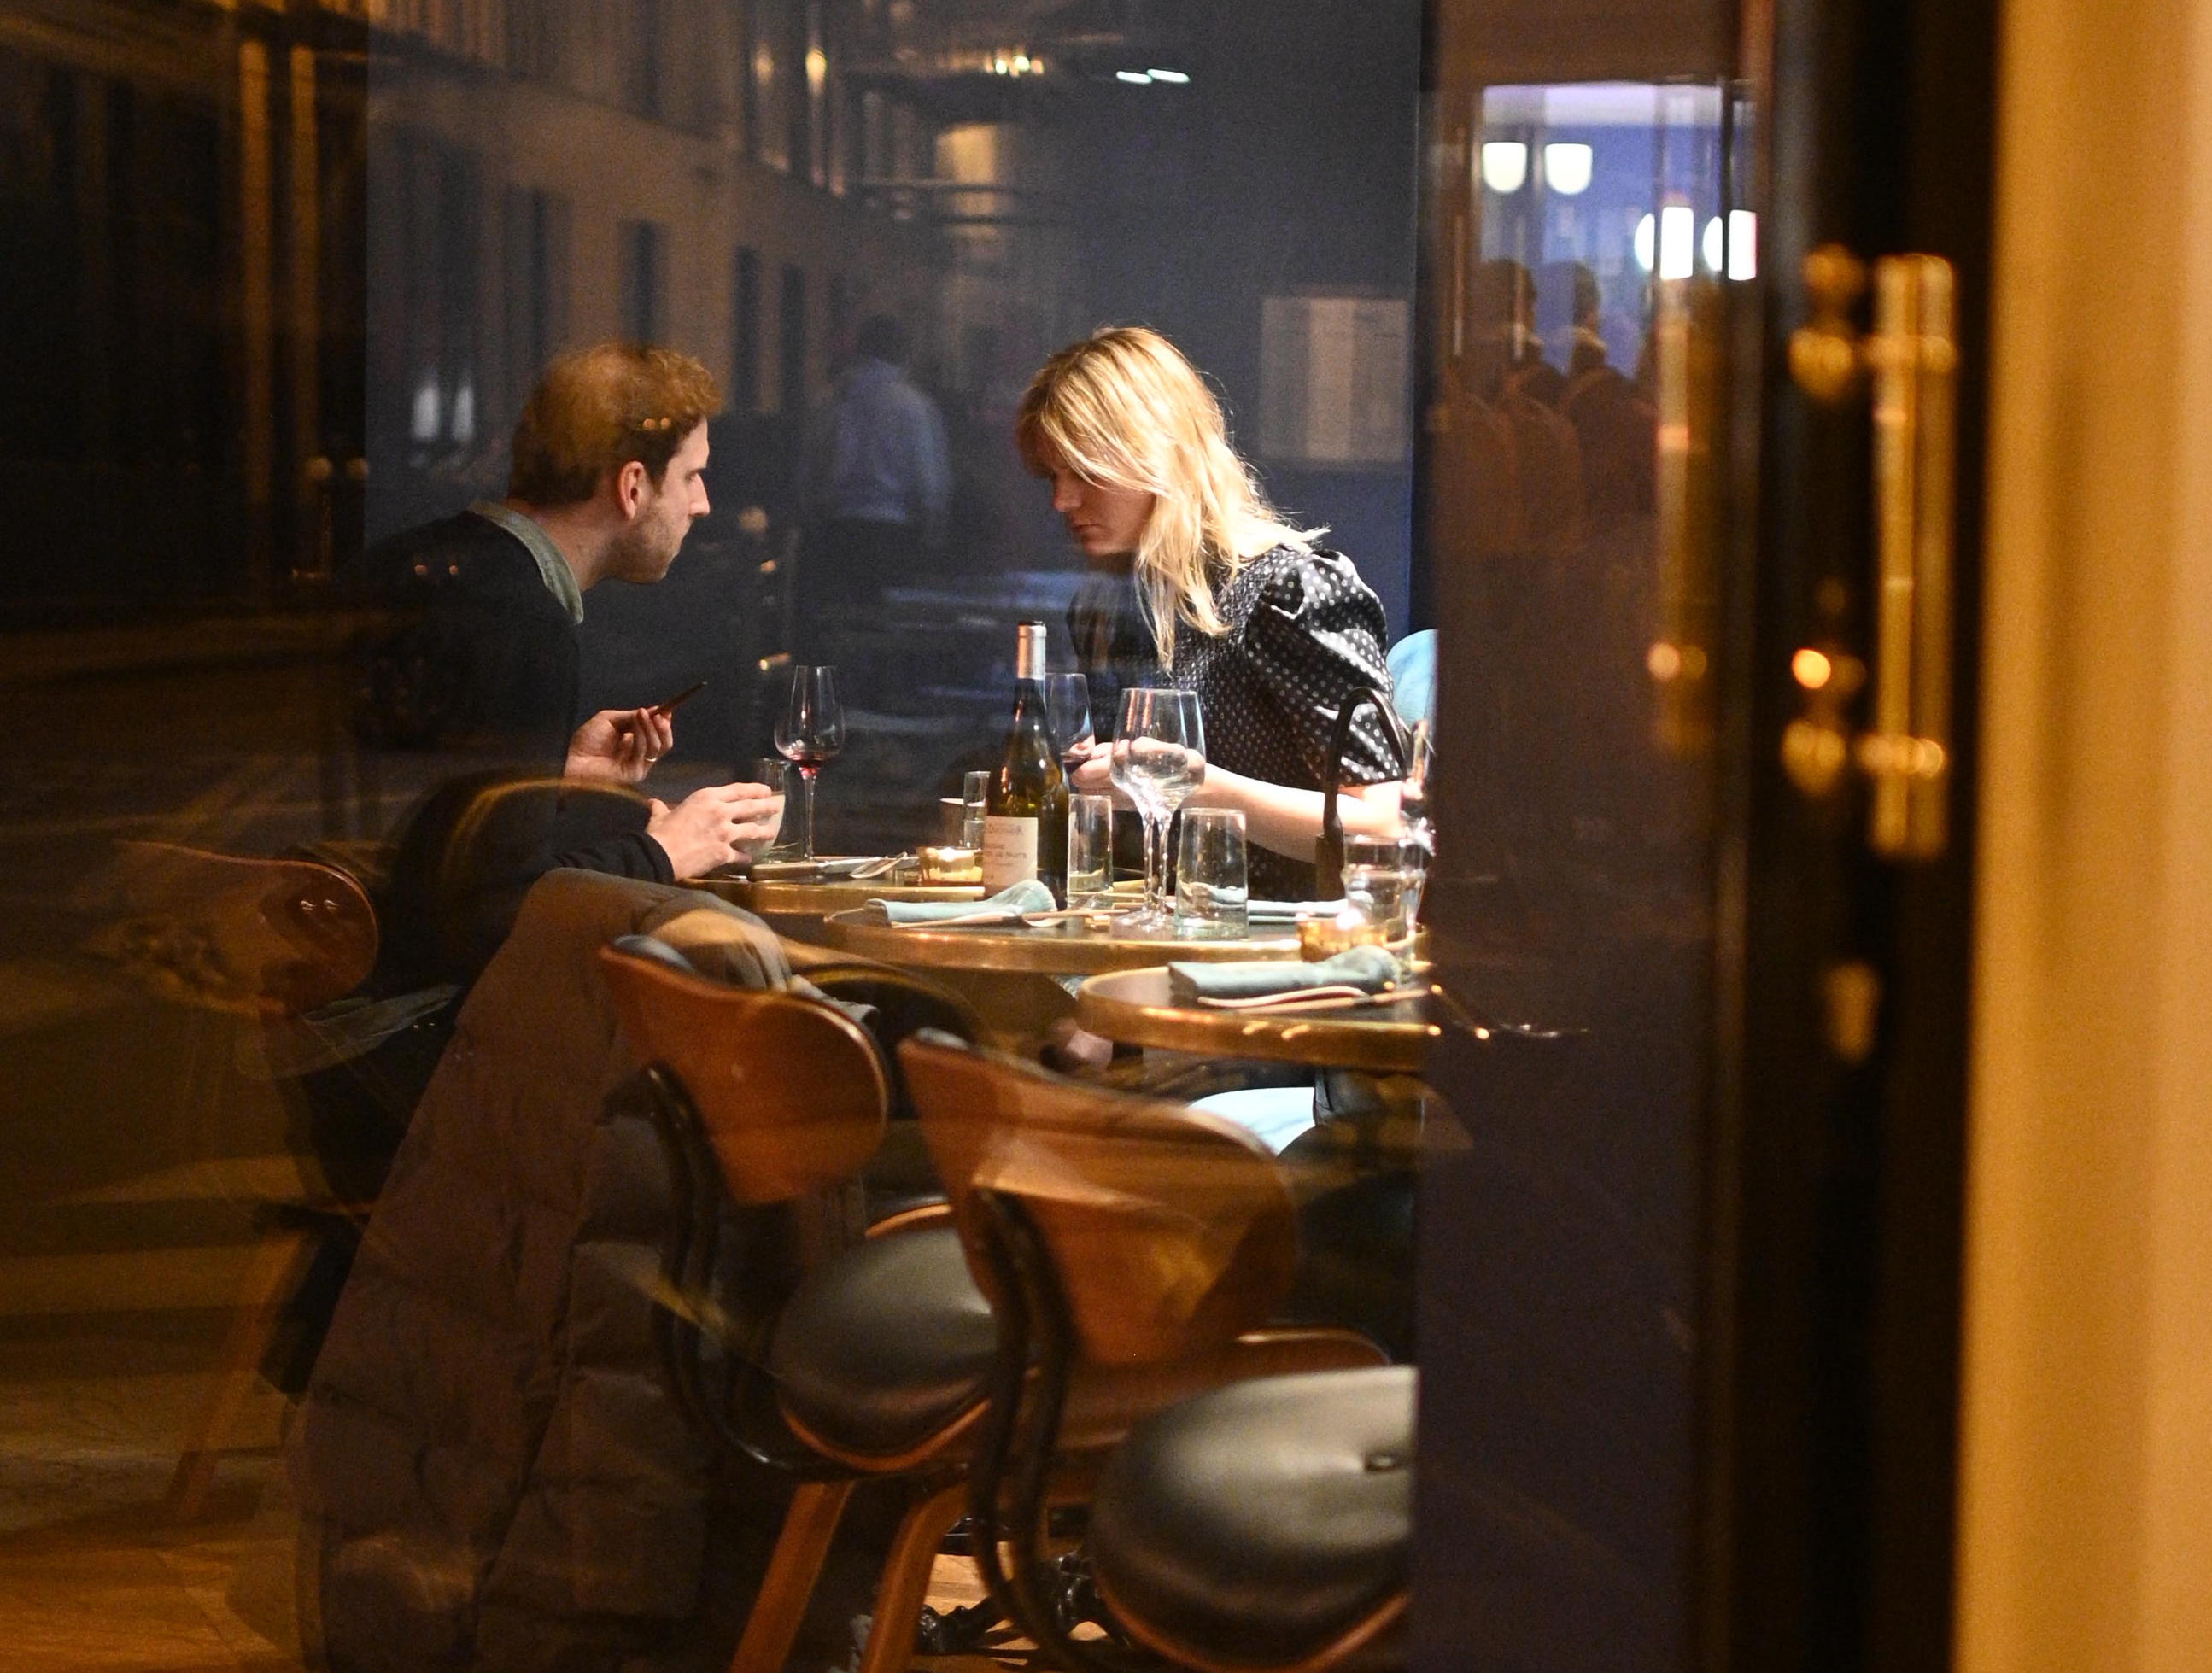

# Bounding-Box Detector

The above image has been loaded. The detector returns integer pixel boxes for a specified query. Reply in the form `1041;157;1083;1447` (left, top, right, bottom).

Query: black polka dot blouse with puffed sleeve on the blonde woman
1166;544;1400;901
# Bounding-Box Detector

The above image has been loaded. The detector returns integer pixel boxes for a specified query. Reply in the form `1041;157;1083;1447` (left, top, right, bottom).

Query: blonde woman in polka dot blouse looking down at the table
1015;325;1398;901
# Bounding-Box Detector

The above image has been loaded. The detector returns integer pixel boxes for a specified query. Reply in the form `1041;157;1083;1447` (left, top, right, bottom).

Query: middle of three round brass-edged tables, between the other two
822;907;1298;1049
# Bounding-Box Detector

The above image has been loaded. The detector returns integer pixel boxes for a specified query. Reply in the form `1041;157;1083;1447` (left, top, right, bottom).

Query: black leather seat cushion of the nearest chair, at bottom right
1091;1366;1413;1669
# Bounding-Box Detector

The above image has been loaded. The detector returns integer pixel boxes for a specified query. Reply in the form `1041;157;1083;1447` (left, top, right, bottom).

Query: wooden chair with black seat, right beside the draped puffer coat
601;943;996;1673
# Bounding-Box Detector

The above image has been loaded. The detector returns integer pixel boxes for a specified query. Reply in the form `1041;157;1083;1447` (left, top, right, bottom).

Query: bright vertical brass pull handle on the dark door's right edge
1783;246;1957;858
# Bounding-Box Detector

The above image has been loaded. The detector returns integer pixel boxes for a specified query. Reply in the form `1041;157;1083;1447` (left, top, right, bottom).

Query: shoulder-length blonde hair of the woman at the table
1013;325;1323;666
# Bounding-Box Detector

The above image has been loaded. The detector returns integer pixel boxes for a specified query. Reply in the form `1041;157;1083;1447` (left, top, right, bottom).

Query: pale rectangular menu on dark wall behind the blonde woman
1259;295;1411;469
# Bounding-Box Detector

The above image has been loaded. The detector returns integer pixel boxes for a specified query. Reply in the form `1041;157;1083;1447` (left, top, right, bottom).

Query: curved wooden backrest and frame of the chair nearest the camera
900;1036;1383;1655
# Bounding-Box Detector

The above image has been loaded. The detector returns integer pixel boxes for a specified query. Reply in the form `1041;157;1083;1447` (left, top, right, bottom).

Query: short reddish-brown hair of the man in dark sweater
506;343;721;506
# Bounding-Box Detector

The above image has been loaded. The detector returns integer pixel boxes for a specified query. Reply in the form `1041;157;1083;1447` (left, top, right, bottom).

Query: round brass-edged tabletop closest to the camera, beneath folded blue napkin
1075;965;1440;1073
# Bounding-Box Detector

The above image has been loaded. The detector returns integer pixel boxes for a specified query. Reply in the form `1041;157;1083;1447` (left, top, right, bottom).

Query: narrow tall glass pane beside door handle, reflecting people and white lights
1413;64;1756;1669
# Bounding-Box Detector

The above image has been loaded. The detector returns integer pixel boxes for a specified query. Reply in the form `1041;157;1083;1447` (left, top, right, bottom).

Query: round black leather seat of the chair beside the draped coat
768;1224;998;1456
